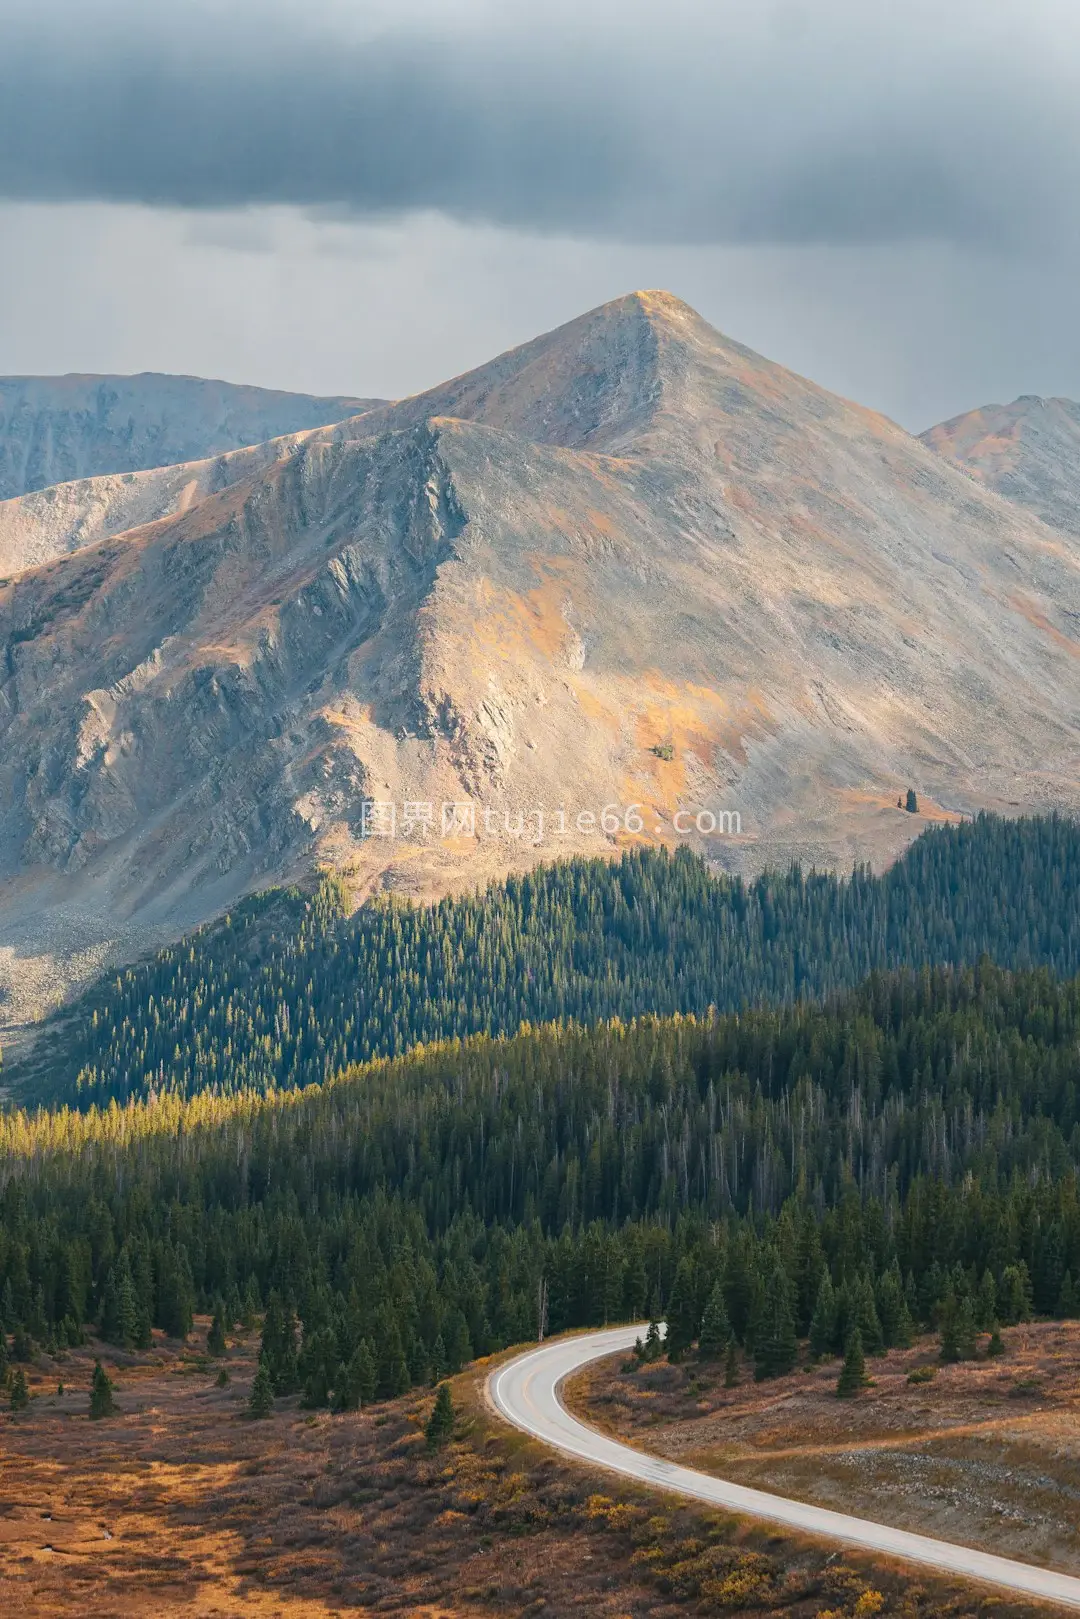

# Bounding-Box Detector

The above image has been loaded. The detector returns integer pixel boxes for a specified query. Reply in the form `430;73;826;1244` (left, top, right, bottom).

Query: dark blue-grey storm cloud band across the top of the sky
0;0;1080;248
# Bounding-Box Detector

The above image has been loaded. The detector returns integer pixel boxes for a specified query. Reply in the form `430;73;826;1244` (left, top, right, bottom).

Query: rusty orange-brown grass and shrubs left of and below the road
0;1321;1062;1619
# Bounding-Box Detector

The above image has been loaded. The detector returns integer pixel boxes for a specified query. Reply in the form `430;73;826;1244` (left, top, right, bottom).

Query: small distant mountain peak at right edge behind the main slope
923;393;1080;538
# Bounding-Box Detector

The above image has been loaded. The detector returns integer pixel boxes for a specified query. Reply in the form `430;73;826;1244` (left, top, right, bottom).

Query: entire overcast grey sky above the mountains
0;0;1080;427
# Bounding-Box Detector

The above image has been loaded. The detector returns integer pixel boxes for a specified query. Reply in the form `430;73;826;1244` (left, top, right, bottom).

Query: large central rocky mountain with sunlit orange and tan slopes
0;293;1080;1015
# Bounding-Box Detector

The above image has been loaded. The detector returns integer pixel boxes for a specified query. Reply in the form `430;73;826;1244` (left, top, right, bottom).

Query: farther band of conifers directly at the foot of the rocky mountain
14;816;1080;1106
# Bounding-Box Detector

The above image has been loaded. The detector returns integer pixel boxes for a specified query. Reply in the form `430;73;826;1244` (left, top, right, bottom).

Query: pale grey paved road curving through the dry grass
487;1326;1080;1608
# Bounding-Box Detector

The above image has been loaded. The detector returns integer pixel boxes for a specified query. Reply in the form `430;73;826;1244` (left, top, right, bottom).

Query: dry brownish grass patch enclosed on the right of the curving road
572;1323;1080;1574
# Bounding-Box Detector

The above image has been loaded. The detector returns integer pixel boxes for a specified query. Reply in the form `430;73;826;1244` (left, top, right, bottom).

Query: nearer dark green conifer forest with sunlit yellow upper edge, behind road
0;960;1080;1407
